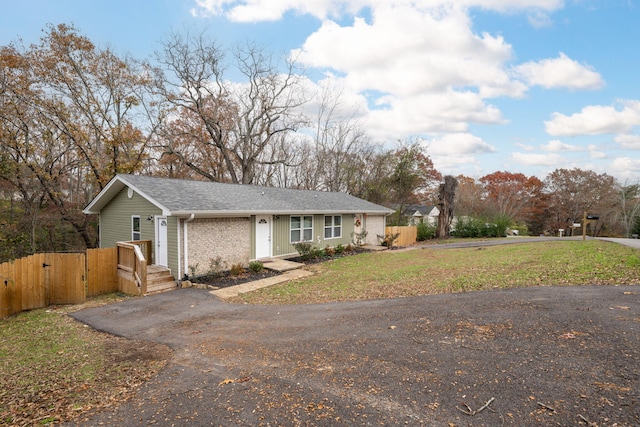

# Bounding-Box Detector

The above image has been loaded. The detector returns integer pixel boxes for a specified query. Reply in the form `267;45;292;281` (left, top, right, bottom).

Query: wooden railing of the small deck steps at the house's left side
116;240;151;295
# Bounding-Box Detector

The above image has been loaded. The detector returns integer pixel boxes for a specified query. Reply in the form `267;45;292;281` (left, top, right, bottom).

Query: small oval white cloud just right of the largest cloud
514;52;604;89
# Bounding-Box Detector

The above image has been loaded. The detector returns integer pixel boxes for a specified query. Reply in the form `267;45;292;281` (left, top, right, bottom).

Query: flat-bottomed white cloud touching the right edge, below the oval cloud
544;100;640;136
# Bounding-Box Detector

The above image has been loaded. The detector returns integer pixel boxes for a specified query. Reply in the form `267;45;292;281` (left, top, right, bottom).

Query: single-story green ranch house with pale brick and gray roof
83;175;393;279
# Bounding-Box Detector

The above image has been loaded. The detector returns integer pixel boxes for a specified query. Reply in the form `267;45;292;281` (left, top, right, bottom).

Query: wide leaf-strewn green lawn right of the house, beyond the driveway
235;240;640;304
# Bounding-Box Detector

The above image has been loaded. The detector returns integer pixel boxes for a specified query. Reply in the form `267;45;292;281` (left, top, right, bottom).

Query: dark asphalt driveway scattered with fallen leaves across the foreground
69;286;640;426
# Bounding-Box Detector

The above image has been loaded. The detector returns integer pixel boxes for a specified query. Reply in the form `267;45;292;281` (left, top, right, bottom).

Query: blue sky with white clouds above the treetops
0;0;640;182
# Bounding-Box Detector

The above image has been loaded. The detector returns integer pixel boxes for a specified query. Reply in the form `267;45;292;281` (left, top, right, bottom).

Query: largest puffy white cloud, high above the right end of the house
293;4;526;97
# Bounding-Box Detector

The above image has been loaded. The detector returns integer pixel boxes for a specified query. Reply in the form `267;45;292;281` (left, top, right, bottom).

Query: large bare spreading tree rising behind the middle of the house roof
152;34;305;184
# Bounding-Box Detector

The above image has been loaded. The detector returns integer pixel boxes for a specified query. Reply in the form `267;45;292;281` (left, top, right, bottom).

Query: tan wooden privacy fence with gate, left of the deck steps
0;248;118;319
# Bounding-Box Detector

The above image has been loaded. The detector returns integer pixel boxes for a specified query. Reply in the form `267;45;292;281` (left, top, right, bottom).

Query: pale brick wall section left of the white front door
188;218;251;275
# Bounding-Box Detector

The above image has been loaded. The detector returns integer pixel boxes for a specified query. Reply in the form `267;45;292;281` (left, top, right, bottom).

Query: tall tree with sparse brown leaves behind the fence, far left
0;25;154;253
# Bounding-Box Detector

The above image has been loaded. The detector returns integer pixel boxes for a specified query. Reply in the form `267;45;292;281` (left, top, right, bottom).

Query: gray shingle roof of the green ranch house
85;175;392;215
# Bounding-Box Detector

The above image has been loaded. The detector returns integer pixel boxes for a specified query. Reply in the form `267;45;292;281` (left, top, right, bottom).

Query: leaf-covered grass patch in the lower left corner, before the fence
0;296;170;426
